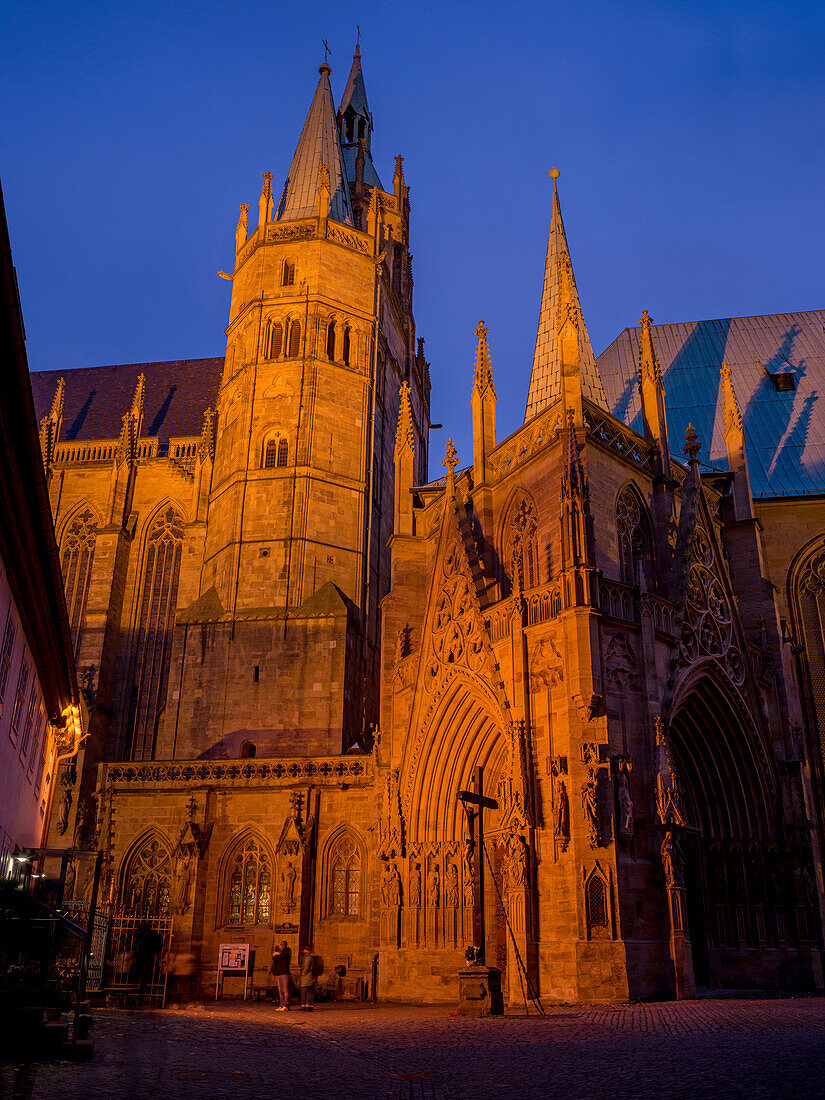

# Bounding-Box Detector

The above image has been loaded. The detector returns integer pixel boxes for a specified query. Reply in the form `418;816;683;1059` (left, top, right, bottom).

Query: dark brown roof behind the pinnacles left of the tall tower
31;356;223;442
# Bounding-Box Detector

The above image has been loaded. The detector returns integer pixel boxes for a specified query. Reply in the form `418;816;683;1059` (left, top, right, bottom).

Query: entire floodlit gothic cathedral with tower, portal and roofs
32;50;825;1005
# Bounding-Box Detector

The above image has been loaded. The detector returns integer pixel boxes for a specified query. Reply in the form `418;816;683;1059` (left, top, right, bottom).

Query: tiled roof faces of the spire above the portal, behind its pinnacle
525;179;607;424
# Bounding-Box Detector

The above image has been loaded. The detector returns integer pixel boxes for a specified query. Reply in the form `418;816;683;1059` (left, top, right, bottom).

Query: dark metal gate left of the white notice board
103;910;172;1008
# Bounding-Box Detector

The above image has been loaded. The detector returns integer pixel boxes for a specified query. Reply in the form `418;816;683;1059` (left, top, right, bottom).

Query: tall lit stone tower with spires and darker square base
154;52;429;757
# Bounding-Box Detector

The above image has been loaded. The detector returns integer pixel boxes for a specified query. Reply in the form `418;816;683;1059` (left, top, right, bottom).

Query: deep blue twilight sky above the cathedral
0;0;825;476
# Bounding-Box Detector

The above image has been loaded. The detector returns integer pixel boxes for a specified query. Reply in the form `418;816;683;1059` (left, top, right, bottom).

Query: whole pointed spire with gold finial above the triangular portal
525;167;607;422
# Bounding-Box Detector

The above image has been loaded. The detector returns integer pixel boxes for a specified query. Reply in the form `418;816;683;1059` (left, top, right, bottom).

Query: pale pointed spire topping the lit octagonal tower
276;62;354;226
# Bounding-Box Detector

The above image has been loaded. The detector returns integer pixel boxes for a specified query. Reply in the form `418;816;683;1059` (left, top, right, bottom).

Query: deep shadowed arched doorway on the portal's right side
670;674;787;987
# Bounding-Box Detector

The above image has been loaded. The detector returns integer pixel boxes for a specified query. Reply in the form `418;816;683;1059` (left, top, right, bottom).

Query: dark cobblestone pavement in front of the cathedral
0;998;825;1100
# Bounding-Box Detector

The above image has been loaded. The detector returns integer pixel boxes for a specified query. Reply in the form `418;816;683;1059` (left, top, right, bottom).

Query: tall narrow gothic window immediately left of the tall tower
129;505;184;760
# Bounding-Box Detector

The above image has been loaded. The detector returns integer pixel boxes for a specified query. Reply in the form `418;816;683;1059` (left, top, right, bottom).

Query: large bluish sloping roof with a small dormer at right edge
597;309;825;497
